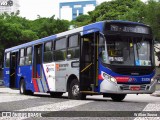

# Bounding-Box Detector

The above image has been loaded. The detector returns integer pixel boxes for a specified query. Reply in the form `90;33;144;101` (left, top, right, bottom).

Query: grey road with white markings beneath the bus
0;88;160;120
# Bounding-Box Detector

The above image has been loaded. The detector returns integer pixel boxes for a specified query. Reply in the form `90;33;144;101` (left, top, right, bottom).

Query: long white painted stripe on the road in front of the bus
18;100;93;111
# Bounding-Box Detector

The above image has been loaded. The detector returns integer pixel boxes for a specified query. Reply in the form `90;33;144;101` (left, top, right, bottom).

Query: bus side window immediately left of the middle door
25;47;32;65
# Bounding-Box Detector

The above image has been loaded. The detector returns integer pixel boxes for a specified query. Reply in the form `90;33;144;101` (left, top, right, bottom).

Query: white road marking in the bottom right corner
134;103;160;120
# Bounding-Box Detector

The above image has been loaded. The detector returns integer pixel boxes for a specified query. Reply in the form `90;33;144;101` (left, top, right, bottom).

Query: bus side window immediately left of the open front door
67;35;79;59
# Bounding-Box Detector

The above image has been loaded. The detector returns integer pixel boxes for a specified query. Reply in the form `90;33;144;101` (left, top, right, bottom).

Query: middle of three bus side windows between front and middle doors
54;38;66;61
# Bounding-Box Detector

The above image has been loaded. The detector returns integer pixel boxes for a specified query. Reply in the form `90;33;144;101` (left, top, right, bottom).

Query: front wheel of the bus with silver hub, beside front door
68;79;86;100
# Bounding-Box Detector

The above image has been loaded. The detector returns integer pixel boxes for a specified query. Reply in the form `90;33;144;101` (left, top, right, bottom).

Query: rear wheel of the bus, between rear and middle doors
19;79;33;95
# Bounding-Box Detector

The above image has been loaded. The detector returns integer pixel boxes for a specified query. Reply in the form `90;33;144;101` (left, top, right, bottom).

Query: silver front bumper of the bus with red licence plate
100;80;157;94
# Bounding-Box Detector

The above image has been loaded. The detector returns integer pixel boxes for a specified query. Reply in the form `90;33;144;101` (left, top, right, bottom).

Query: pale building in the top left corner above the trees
0;0;19;14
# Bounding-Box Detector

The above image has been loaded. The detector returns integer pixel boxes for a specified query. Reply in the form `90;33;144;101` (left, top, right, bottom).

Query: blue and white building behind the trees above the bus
59;0;96;21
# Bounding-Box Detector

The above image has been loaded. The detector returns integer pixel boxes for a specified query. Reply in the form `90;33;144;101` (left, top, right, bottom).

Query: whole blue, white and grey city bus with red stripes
3;20;156;101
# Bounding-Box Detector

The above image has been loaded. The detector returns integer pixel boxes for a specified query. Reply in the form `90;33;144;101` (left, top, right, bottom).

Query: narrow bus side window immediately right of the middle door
43;41;53;62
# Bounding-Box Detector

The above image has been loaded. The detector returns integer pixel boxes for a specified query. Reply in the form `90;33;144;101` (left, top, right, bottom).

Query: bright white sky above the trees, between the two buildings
19;0;145;20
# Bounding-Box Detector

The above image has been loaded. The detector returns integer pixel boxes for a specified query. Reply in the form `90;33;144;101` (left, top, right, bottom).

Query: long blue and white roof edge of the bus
5;20;148;52
